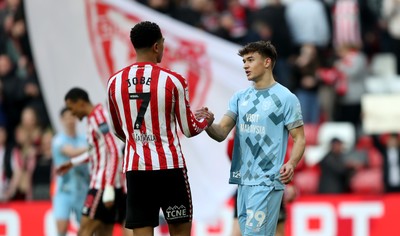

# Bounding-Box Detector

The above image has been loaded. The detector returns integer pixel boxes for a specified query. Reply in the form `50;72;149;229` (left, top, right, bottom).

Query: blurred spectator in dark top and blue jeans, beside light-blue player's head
293;44;320;124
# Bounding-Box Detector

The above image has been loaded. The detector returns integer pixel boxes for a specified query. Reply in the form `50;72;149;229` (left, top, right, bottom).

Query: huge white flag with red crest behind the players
25;0;249;222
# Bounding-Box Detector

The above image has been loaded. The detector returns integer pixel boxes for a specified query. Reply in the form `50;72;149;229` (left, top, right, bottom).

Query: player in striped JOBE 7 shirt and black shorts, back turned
107;21;214;235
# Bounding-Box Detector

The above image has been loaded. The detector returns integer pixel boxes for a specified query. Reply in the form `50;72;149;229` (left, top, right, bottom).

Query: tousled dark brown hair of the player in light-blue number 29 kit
238;40;278;67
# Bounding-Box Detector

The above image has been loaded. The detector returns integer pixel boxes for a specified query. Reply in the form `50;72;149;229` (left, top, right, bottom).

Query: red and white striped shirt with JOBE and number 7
107;62;207;172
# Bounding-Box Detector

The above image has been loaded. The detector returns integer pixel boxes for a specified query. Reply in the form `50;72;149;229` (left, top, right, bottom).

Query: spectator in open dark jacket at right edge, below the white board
372;133;400;193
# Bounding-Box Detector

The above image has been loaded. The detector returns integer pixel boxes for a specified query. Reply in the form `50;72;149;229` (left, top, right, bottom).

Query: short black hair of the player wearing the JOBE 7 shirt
130;21;162;49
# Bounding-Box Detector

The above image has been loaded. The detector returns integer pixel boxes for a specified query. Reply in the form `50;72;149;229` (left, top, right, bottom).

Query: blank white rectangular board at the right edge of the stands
361;94;400;134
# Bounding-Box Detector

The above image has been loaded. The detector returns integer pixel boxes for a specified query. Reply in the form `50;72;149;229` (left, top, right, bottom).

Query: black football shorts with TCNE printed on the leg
125;169;193;229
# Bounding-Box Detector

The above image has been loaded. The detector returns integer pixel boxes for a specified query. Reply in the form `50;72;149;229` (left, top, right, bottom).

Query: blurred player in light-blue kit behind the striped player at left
52;108;89;236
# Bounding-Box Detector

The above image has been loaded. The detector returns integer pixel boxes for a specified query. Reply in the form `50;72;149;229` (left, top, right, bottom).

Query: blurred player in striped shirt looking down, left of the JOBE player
57;88;126;235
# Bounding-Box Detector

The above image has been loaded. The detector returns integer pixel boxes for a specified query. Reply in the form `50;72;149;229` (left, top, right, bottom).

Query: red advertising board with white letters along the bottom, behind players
0;194;400;236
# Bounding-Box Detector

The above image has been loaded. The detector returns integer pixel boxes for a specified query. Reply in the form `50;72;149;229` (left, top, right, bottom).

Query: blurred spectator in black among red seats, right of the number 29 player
318;138;361;194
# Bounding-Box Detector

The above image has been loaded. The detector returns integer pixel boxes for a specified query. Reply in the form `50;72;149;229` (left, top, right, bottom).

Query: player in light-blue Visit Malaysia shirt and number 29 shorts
196;41;305;236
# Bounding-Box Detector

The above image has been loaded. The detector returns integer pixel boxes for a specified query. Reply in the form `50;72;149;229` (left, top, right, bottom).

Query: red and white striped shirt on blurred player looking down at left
87;104;123;189
